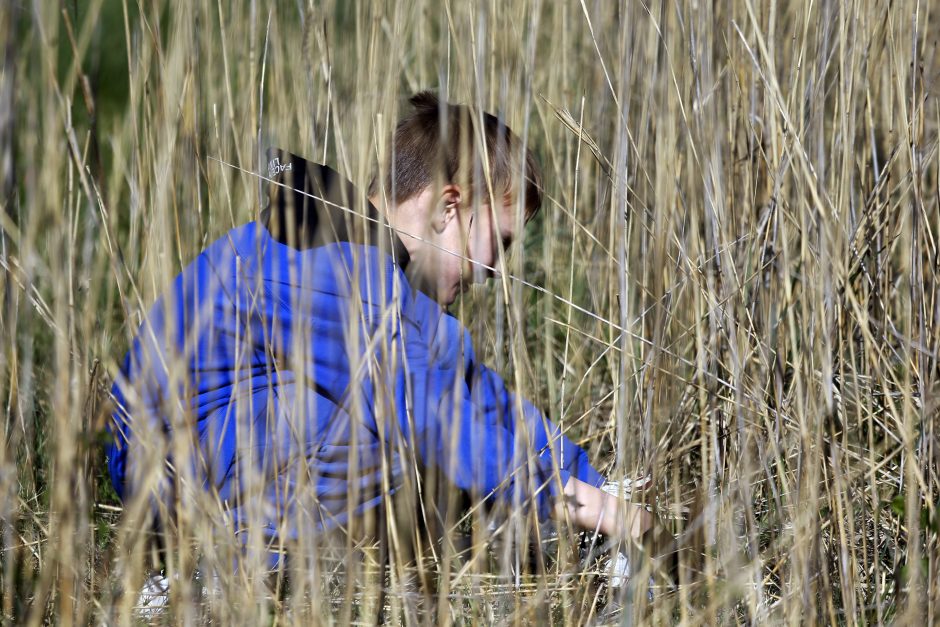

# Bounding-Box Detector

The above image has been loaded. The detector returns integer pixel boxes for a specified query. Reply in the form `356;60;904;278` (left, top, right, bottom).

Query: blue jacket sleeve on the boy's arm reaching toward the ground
388;312;603;519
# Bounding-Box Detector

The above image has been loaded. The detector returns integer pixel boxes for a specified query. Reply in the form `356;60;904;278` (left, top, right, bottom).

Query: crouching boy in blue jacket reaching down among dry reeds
108;92;650;580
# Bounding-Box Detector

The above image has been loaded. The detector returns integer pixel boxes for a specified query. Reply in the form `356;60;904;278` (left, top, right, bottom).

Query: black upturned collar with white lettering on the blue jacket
260;148;409;269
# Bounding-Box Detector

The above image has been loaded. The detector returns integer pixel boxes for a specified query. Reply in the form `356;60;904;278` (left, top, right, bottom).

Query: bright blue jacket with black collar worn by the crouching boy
108;153;603;536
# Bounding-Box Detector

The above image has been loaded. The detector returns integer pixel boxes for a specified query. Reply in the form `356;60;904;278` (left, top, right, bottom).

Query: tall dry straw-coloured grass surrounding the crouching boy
0;0;940;624
